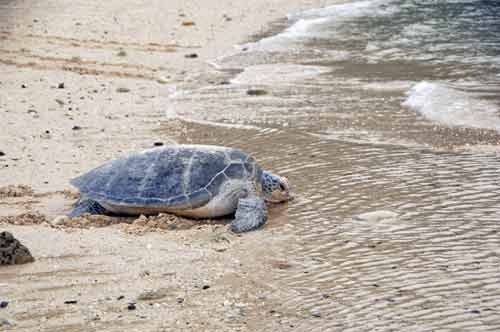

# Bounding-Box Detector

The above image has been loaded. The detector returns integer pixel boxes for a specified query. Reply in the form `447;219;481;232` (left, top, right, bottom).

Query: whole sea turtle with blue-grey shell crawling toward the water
68;145;291;233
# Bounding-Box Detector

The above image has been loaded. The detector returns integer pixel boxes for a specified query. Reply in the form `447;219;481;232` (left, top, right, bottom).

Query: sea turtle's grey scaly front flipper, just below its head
231;196;267;233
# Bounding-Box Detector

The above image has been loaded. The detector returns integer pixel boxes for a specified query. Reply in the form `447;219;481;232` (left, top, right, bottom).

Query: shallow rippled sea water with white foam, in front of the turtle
168;0;500;331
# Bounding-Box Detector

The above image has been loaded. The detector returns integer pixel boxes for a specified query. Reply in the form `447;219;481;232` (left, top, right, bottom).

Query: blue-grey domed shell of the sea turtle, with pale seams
71;145;262;210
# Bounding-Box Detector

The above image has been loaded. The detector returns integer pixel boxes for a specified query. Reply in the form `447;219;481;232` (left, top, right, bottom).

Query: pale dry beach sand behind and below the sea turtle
0;0;336;331
